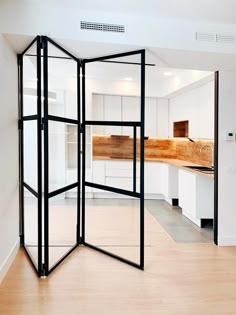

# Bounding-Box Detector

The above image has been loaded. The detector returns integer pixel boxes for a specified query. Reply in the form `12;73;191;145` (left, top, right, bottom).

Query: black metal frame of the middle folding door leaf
42;36;81;276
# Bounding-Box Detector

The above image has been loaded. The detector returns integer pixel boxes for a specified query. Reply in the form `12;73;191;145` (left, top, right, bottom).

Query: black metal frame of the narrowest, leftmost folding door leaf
17;36;42;276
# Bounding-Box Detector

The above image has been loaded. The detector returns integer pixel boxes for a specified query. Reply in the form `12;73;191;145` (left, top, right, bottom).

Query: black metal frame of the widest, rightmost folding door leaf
82;49;145;270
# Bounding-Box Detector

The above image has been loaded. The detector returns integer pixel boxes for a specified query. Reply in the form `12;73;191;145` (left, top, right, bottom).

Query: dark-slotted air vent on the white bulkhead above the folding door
80;21;125;33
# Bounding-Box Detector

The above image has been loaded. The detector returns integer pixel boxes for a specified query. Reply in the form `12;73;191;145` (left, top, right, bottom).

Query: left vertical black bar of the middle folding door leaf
42;36;49;276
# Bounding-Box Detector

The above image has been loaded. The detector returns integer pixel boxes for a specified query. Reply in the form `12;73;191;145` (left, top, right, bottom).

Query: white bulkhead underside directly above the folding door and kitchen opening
5;33;236;71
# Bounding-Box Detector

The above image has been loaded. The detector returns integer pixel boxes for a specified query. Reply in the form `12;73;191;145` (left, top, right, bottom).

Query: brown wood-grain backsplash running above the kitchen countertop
93;136;214;166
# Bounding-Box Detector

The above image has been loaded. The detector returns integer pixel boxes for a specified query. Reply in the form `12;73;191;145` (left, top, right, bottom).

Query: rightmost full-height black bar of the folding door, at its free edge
140;50;145;269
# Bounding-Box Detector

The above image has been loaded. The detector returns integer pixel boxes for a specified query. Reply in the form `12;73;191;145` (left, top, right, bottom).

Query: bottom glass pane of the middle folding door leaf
49;190;77;268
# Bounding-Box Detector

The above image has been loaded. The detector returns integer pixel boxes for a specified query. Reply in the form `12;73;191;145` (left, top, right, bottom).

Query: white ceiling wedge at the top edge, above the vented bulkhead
15;0;236;24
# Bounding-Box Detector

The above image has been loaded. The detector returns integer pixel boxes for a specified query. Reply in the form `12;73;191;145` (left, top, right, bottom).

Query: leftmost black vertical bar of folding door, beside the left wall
17;55;24;245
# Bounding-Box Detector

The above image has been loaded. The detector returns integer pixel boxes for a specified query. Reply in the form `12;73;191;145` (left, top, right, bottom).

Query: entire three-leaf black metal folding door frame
18;36;145;276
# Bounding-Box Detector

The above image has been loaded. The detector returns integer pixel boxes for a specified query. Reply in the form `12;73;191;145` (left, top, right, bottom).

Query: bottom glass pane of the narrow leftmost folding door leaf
24;188;38;267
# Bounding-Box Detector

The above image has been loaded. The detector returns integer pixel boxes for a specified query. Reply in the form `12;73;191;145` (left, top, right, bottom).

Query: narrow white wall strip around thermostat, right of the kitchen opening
218;72;236;245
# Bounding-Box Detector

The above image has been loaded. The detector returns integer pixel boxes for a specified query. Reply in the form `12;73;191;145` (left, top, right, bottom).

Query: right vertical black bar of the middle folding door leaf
77;60;81;245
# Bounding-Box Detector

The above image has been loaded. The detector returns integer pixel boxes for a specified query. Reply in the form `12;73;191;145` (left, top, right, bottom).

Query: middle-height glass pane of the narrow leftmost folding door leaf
23;120;38;191
